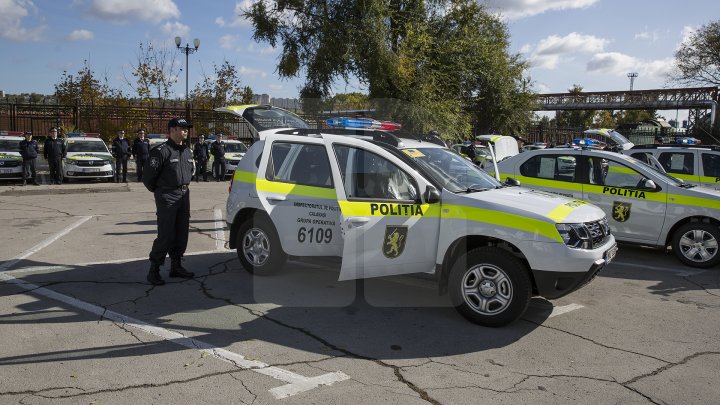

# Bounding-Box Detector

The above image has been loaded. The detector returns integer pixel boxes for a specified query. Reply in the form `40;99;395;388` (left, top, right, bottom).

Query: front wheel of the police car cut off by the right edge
672;222;720;268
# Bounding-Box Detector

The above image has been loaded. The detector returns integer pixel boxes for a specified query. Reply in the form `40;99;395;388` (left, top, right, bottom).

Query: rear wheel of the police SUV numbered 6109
237;214;287;276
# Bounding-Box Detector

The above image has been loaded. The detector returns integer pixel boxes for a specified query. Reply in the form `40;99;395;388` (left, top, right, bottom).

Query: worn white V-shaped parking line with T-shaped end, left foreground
0;217;350;399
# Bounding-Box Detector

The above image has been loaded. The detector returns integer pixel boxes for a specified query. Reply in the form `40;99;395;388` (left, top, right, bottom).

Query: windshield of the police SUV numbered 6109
402;148;502;193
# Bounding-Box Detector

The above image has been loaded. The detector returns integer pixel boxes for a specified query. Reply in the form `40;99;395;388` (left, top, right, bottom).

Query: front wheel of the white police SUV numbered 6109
448;247;532;327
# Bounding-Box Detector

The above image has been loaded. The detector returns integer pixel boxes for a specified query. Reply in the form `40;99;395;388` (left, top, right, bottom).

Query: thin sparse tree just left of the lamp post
123;42;179;108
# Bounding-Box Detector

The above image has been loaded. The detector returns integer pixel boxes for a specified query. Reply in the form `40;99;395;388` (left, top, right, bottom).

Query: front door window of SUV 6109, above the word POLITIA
334;145;418;201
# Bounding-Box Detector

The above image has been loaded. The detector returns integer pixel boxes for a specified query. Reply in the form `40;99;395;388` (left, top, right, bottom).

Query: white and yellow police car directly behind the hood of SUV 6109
498;149;720;267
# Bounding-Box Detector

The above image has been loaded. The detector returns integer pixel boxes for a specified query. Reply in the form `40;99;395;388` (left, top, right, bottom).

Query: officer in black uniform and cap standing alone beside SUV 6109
143;118;195;285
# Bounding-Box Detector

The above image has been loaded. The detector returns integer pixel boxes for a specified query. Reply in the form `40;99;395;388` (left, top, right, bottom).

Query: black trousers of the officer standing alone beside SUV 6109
150;190;190;266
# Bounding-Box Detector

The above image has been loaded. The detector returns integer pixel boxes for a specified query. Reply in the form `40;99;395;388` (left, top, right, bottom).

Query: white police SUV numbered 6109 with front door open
226;122;617;326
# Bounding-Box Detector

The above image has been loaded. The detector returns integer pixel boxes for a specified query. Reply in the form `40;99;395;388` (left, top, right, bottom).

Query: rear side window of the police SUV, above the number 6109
266;142;333;187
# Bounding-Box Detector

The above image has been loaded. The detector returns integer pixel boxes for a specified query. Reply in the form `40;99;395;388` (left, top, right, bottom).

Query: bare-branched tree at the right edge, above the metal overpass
670;21;720;86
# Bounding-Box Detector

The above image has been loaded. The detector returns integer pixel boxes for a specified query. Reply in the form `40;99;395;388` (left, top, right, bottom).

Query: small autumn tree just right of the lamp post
190;61;253;109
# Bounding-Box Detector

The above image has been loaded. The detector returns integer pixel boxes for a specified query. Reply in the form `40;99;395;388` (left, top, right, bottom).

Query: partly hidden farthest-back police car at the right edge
623;144;720;190
